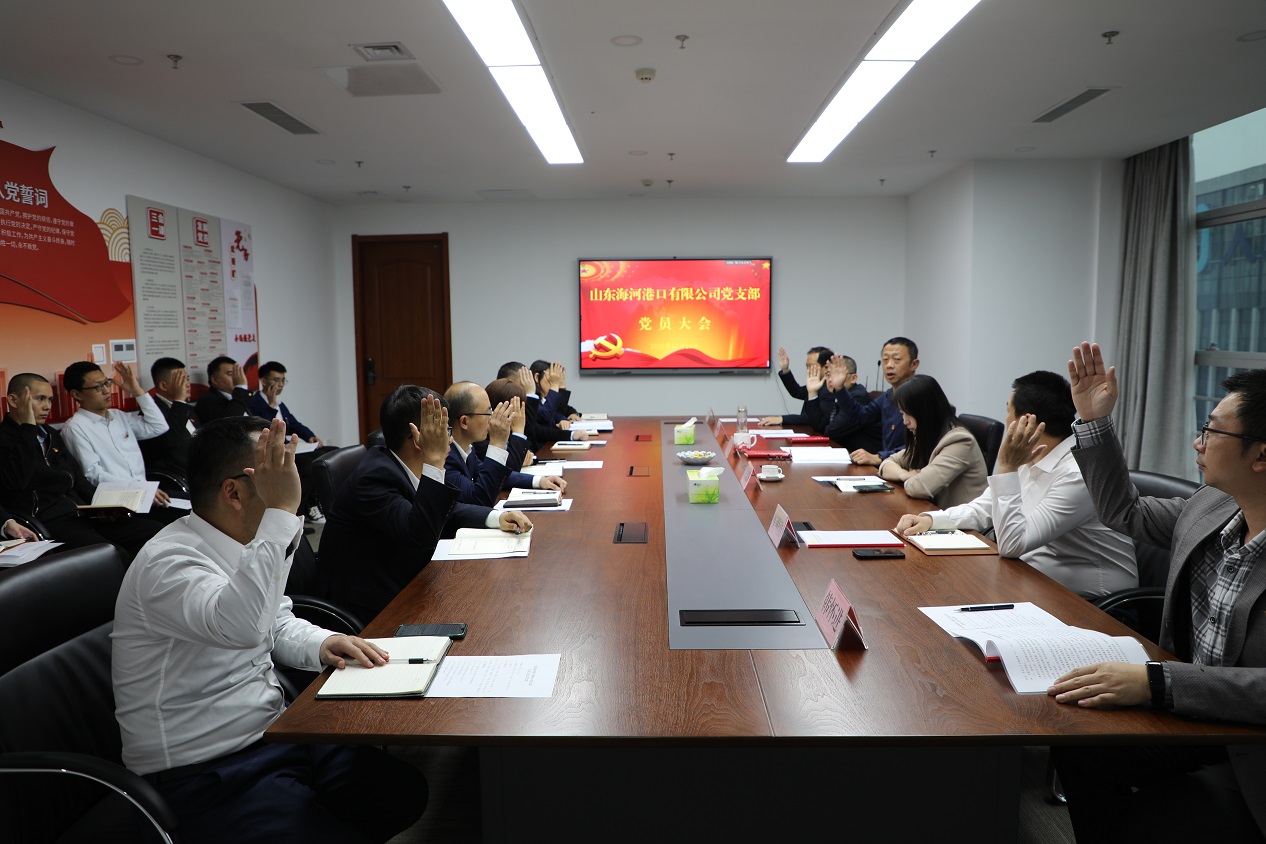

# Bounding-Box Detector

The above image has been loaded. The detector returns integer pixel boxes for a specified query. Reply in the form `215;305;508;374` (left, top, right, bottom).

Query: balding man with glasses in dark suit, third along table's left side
444;381;567;506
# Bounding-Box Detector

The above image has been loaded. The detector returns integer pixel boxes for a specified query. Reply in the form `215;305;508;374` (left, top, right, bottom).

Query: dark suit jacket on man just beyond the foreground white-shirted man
317;445;489;621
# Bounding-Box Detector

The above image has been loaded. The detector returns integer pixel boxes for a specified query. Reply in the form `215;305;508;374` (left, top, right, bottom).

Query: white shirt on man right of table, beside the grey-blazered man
928;437;1138;599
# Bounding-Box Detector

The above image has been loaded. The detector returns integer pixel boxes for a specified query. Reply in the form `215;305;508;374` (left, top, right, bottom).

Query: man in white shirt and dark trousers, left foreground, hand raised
111;418;427;843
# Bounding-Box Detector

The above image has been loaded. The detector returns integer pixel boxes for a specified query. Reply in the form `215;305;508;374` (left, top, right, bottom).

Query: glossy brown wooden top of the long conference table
267;419;1266;745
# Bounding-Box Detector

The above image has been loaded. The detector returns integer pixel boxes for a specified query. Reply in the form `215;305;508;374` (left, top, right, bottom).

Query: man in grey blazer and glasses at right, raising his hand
1050;343;1266;843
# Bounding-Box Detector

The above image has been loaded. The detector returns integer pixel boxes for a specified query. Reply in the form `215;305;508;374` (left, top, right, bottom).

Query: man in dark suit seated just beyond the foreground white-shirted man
317;386;532;619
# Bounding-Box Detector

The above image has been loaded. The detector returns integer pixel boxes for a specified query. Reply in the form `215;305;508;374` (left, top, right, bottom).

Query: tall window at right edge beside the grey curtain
1193;109;1266;428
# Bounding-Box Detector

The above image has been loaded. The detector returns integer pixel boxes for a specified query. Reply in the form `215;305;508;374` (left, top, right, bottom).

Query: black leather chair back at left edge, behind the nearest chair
0;545;123;674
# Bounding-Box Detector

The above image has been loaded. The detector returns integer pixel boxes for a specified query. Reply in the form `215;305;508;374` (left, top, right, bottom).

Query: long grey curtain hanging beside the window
1117;138;1196;480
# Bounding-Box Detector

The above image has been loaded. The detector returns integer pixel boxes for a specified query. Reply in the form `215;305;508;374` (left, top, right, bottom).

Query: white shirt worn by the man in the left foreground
110;509;333;774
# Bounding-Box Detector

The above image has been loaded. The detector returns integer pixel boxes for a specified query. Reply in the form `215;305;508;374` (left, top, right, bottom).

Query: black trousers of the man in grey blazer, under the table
1051;745;1266;844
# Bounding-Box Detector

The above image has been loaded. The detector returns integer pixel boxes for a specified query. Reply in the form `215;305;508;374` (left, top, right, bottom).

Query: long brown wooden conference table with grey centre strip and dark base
266;419;1266;841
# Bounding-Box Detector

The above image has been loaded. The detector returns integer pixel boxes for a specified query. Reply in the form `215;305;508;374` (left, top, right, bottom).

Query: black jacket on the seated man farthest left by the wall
0;414;95;519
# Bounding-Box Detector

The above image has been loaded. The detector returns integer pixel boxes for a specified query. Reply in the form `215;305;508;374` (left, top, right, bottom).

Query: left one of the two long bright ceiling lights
444;0;585;164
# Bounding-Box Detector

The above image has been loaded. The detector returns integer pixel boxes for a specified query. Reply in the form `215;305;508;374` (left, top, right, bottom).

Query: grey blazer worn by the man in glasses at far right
1072;437;1266;833
